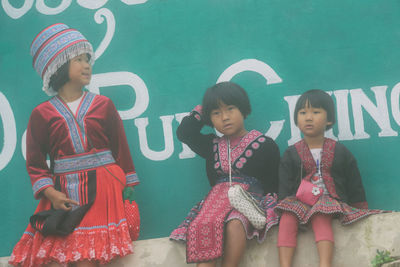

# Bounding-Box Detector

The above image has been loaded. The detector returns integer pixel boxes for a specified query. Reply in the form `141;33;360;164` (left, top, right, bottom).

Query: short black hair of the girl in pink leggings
294;89;336;130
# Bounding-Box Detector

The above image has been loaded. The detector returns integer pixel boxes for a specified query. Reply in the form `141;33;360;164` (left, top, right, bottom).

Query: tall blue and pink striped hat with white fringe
31;23;94;96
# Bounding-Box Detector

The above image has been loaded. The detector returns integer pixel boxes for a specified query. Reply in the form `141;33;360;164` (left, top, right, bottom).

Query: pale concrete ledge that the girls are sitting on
0;212;400;267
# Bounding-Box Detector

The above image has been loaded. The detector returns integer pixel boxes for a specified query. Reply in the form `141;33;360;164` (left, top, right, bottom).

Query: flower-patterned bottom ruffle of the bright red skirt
10;221;133;266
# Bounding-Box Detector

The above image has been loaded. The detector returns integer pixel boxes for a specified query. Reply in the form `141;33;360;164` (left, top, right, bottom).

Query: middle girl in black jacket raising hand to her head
170;82;280;267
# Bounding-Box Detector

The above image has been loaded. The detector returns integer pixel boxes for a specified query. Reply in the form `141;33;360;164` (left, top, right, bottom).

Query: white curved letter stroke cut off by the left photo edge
0;92;17;171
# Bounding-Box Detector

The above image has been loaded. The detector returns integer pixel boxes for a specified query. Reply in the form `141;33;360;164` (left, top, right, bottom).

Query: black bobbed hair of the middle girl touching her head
202;82;251;126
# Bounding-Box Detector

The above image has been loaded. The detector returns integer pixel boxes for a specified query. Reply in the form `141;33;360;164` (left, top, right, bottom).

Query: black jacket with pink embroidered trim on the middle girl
176;107;280;193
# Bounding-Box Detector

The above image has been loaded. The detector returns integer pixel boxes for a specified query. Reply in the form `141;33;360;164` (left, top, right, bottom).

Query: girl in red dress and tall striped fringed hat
10;23;139;267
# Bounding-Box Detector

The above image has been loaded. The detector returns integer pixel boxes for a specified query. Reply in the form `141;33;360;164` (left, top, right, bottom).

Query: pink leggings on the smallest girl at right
278;212;334;248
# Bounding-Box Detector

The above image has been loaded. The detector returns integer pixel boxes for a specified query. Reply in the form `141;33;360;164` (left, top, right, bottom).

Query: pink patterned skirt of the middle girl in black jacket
170;178;279;263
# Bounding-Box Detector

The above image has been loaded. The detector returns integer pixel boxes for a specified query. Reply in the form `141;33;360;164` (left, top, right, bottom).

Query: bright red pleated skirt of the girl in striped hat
9;164;133;267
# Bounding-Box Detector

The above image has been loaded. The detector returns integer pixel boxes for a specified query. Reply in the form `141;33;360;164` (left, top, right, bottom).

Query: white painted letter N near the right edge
350;86;397;139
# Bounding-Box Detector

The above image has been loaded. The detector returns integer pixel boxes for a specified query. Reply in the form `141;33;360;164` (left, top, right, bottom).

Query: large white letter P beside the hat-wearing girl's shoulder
88;71;149;120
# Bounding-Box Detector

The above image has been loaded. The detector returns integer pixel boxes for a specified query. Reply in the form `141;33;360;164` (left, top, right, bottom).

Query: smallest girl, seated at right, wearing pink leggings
276;90;380;267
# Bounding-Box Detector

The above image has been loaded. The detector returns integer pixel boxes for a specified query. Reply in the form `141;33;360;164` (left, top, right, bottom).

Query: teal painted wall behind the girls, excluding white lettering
0;0;400;256
